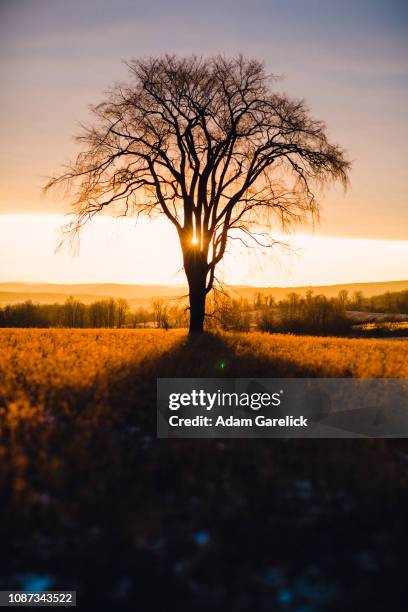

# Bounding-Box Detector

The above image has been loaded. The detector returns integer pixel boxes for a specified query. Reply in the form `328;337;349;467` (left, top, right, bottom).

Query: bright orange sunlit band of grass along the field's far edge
0;329;408;403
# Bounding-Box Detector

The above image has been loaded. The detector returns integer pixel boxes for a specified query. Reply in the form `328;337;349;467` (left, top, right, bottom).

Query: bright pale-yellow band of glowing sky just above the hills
0;214;408;286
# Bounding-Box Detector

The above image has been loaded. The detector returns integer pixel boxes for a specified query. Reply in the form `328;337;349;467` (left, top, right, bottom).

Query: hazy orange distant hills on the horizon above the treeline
0;280;408;308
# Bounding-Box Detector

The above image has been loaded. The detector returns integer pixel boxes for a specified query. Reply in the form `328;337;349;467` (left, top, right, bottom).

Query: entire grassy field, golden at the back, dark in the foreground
0;330;408;612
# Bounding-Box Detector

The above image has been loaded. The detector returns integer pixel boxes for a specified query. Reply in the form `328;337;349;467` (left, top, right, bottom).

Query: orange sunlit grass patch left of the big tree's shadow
0;329;184;403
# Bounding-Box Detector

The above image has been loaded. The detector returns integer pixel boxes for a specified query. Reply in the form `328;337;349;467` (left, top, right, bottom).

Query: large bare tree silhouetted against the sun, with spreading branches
46;55;349;332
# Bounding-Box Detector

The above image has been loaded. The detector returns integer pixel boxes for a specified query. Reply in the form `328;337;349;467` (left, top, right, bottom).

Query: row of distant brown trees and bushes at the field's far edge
0;291;408;335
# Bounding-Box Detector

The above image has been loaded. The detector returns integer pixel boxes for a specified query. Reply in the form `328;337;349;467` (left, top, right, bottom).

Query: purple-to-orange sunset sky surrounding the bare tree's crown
0;0;408;285
